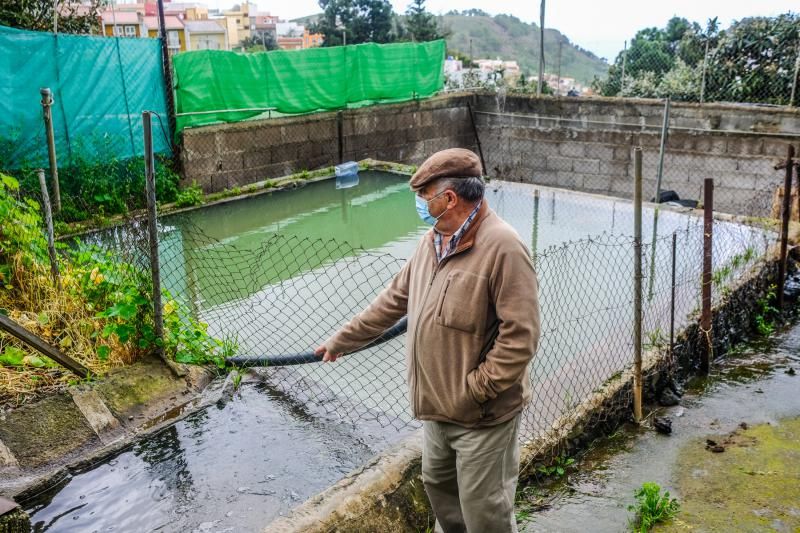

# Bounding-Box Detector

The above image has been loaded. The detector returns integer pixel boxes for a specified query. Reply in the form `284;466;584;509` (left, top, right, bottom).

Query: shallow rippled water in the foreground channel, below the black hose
24;384;410;533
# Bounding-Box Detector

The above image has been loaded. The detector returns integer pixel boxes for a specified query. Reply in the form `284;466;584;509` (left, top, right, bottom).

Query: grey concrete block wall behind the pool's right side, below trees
475;96;800;216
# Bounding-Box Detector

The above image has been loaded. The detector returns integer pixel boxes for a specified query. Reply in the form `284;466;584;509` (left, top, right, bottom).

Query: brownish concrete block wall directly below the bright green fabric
181;96;475;192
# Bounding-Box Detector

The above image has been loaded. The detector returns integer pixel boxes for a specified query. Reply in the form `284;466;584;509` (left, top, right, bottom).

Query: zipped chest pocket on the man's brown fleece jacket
436;270;489;334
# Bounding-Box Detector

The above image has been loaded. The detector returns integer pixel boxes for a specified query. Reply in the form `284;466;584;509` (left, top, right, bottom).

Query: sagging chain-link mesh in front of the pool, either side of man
69;163;774;474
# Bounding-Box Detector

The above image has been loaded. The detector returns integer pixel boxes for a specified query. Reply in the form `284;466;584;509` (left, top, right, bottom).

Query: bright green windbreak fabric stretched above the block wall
173;40;445;131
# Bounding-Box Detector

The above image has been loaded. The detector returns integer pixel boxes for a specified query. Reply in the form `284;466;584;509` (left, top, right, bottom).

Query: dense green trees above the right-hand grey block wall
593;13;800;105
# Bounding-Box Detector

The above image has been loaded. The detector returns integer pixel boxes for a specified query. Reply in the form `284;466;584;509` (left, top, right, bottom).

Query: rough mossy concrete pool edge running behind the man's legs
263;255;797;533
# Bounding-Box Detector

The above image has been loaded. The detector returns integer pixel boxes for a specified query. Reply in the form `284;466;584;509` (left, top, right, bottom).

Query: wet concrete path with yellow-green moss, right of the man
517;325;800;532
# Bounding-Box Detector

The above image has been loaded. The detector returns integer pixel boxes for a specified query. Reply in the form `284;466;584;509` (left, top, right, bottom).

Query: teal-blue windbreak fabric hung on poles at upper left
0;26;169;169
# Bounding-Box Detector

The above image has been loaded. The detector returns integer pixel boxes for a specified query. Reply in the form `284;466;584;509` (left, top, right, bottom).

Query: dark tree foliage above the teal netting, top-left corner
0;0;105;33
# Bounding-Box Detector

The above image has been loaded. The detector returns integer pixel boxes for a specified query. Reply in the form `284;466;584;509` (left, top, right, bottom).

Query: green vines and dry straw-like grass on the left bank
0;174;233;407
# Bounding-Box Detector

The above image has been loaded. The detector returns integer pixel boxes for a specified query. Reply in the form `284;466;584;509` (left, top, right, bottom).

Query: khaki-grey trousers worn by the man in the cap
422;415;520;533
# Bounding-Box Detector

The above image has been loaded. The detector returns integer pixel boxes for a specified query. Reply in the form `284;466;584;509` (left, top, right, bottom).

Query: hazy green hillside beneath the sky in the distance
442;14;608;84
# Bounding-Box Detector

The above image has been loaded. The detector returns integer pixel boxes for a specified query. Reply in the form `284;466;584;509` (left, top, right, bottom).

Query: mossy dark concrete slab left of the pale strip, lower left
0;394;100;468
